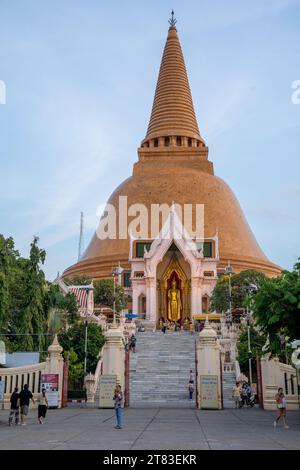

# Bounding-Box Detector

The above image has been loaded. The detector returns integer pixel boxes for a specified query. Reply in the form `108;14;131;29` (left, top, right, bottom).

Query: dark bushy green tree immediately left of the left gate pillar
59;322;105;373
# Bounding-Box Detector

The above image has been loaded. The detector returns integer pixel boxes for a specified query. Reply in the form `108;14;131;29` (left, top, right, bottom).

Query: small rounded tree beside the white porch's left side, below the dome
94;279;128;312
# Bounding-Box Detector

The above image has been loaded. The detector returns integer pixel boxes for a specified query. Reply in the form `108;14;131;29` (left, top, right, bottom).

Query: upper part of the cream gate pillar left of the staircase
102;324;125;392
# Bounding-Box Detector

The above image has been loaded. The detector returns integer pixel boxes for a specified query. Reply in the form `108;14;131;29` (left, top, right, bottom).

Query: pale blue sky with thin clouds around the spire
0;0;300;279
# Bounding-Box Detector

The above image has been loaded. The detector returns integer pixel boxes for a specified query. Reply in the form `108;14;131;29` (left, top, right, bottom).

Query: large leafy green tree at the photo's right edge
253;262;300;356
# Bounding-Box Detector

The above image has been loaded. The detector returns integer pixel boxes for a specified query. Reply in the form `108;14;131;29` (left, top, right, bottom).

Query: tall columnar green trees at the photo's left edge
0;235;47;351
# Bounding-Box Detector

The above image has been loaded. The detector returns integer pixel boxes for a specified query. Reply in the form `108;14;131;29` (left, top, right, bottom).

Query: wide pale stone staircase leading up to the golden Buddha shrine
129;331;197;408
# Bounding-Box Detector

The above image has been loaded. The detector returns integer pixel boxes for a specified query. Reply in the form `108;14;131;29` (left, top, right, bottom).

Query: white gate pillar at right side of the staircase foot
196;315;222;409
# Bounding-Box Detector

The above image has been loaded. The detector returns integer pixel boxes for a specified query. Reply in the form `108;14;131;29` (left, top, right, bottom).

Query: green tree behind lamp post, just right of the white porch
211;270;265;312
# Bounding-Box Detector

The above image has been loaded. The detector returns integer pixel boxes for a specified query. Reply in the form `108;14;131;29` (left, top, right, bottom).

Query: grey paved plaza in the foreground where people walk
0;408;300;450
